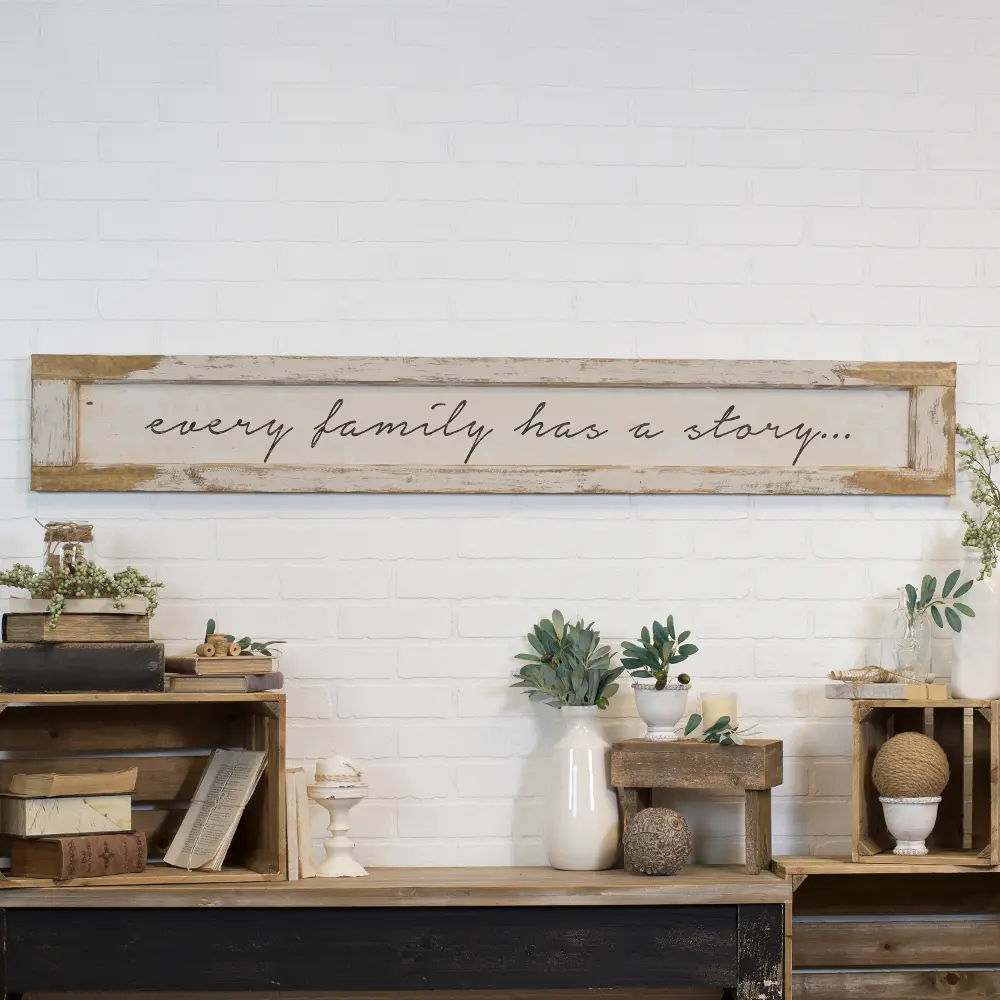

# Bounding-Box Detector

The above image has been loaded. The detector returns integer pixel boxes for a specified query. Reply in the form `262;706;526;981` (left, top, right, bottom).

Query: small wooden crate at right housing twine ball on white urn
852;700;1000;867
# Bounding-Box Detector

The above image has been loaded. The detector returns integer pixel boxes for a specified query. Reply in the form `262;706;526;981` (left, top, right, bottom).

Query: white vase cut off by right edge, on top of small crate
951;553;1000;699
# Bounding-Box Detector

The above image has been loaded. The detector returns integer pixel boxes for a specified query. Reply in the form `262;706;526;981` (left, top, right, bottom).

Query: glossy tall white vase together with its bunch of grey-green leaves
511;611;625;871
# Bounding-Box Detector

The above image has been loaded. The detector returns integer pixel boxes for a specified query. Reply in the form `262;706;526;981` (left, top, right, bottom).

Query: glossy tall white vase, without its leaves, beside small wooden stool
545;707;618;871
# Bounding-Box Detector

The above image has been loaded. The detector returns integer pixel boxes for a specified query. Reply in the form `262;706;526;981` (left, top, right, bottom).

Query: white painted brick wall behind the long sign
0;0;1000;864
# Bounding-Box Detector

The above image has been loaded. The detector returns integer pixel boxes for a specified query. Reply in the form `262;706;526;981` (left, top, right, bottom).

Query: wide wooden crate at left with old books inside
0;692;286;888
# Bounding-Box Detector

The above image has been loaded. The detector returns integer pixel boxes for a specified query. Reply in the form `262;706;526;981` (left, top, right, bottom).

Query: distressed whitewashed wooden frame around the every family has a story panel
31;355;956;496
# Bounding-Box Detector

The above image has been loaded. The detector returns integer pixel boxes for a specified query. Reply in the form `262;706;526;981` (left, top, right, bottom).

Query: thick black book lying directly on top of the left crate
0;642;163;694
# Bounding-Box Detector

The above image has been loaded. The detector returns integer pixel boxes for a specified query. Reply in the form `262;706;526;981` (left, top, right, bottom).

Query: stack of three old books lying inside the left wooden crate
0;767;146;879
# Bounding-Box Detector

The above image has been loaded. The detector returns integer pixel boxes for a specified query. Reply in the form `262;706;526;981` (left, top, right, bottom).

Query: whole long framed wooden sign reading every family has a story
31;355;955;494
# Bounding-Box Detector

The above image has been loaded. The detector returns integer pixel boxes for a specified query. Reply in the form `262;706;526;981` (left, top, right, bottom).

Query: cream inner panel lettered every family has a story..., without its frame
79;385;910;469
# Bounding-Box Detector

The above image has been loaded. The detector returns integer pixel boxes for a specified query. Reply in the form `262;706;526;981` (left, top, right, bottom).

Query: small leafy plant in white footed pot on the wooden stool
622;615;698;740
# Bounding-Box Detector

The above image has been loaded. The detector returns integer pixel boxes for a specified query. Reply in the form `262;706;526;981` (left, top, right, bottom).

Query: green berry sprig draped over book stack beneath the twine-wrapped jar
0;562;163;630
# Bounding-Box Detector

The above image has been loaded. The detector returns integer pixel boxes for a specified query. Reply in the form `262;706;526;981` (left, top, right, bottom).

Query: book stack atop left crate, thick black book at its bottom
0;598;164;694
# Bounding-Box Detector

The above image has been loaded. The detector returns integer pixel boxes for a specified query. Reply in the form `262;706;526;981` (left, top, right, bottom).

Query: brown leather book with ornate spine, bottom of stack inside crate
10;833;146;879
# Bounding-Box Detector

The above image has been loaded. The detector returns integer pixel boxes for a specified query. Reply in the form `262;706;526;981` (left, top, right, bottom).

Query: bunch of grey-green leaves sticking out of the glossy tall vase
511;611;625;709
